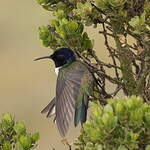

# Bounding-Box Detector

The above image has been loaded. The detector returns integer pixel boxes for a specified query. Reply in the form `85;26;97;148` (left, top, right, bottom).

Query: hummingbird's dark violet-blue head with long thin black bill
35;48;76;67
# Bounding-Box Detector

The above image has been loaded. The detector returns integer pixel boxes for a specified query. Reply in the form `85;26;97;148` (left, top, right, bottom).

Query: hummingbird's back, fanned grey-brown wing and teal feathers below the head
55;61;93;136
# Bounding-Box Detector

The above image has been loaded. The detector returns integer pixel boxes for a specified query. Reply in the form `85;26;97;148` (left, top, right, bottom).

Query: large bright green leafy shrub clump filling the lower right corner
75;96;150;150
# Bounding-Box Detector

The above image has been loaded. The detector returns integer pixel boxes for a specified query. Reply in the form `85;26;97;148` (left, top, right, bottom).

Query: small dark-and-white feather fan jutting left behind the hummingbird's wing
41;97;55;118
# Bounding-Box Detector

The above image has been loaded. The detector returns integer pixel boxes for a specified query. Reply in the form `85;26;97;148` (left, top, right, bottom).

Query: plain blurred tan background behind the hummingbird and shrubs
0;0;111;150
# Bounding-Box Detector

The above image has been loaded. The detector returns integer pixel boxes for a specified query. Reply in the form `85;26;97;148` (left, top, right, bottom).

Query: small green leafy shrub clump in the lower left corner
0;113;39;150
